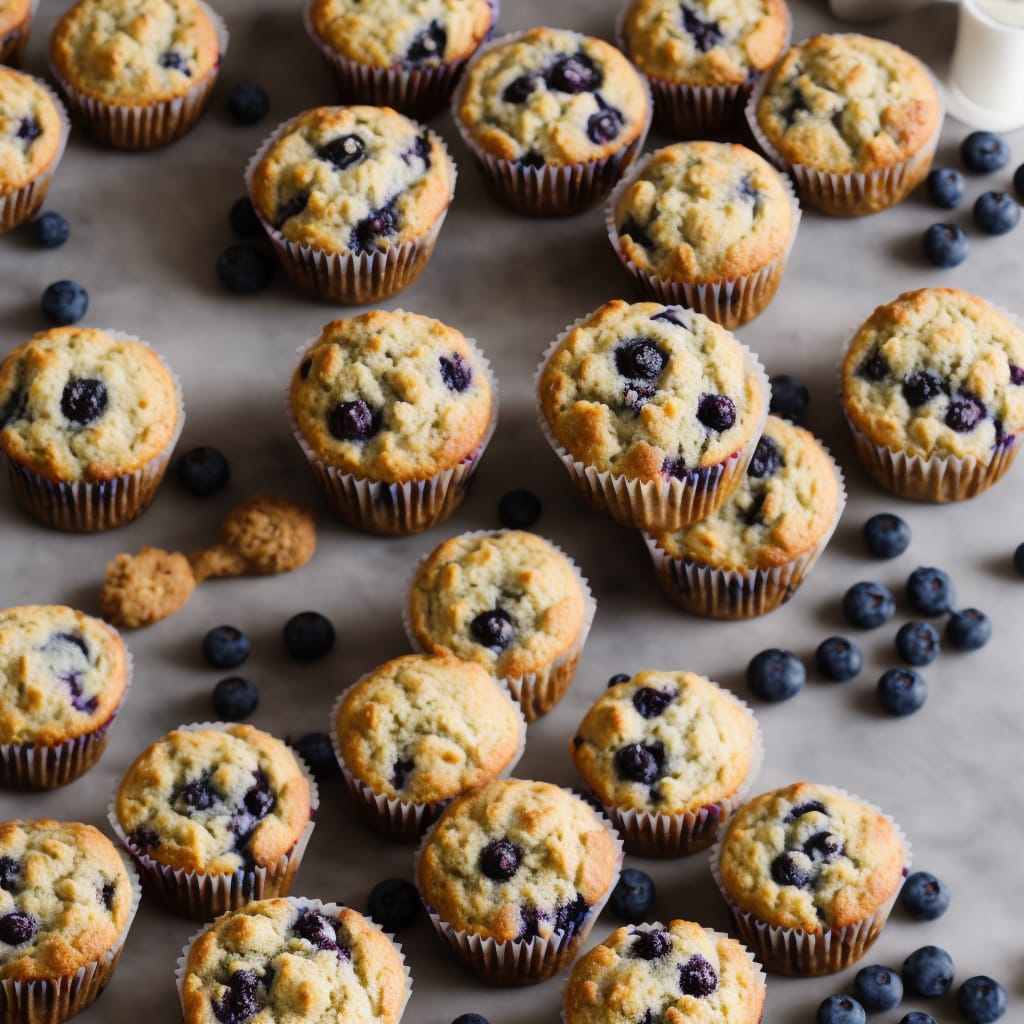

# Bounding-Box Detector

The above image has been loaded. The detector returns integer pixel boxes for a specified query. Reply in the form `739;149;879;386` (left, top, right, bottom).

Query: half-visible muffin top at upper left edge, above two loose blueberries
0;66;63;196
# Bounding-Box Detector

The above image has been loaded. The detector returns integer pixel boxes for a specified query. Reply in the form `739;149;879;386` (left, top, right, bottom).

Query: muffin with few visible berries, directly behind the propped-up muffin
608;142;799;328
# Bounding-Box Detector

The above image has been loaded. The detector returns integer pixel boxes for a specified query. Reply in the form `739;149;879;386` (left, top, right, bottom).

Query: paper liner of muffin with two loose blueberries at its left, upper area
245;115;459;305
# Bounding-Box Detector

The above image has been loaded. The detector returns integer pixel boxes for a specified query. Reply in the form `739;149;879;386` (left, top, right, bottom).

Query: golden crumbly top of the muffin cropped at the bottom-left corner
0;820;133;981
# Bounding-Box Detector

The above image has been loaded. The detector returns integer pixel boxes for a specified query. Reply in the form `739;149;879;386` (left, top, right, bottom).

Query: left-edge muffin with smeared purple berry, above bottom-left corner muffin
0;604;129;790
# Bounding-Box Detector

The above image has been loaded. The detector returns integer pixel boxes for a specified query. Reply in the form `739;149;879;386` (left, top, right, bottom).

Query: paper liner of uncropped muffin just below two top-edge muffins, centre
452;32;653;217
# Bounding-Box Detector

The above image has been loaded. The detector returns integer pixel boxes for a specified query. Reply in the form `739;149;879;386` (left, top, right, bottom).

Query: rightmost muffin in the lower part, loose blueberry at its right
713;782;909;975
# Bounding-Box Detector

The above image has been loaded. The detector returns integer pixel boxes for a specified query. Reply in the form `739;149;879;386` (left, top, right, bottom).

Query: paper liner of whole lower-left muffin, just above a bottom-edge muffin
106;722;319;921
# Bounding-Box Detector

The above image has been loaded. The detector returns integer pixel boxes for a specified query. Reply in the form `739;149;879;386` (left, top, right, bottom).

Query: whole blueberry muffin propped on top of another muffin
537;299;768;530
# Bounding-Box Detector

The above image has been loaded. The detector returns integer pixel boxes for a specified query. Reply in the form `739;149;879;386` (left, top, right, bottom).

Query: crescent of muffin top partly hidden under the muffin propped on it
654;416;840;569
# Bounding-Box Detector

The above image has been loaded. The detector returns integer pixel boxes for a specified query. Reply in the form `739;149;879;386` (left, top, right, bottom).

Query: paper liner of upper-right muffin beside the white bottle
745;38;944;217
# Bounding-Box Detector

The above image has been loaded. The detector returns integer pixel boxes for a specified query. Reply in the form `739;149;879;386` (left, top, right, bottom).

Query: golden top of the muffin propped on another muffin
538;299;766;480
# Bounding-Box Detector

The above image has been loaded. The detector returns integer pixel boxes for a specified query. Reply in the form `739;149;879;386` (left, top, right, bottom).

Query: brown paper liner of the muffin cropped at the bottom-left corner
0;850;142;1024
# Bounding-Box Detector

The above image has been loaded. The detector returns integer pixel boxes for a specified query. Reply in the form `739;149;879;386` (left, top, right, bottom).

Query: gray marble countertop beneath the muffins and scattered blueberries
0;0;1024;1024
